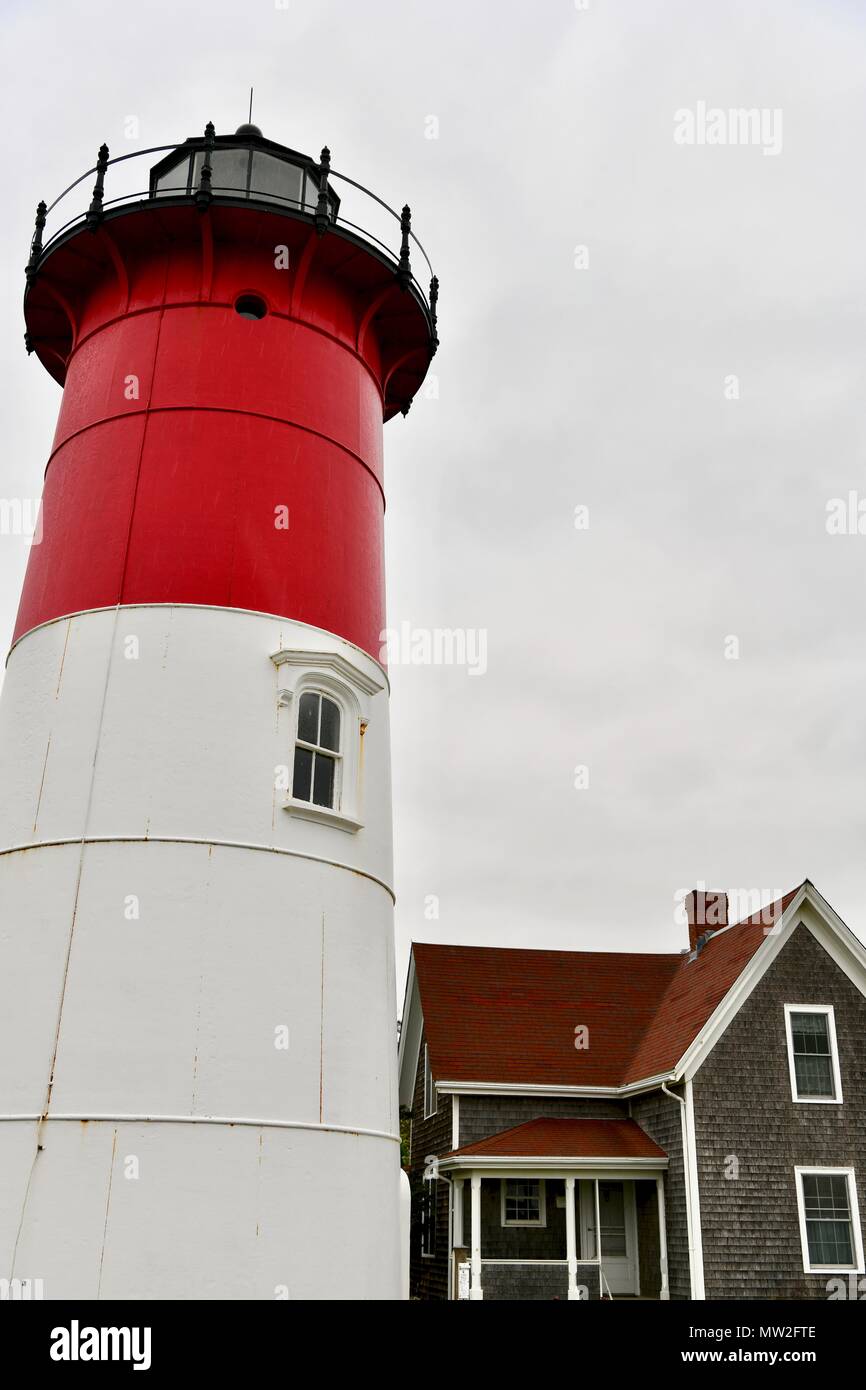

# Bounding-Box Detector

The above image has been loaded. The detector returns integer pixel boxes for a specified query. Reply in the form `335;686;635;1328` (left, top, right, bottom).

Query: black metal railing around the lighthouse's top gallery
26;121;439;340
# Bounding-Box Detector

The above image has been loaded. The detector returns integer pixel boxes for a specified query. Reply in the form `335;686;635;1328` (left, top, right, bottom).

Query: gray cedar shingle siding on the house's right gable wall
695;926;866;1298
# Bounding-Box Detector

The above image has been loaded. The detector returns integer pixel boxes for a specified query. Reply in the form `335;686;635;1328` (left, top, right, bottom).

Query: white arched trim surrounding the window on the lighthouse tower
271;649;385;834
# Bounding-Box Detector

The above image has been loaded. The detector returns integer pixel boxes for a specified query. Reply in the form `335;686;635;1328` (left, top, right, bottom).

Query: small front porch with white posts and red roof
439;1119;669;1301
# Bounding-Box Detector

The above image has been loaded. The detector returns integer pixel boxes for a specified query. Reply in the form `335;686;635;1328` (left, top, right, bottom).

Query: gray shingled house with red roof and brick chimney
400;881;866;1300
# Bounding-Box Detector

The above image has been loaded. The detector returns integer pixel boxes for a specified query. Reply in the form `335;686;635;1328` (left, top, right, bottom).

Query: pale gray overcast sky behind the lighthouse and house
0;0;866;991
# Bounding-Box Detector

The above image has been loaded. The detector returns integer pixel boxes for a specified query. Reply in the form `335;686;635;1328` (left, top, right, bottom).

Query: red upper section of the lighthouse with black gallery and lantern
15;135;436;656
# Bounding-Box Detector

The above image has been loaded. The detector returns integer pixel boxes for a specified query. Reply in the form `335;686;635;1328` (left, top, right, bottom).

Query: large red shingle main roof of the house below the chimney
413;888;798;1087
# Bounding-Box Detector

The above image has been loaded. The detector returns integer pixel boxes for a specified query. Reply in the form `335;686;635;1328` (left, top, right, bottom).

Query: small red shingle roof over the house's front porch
448;1119;667;1158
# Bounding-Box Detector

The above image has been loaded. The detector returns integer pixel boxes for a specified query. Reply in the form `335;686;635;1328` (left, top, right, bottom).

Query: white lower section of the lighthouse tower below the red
0;606;400;1300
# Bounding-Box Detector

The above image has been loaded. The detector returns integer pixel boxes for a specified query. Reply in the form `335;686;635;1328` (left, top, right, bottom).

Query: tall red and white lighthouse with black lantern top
0;125;438;1300
